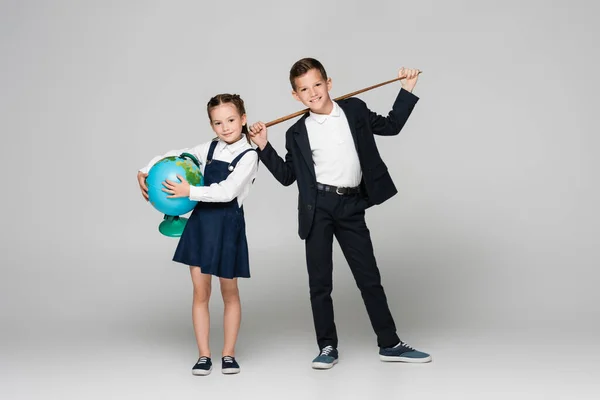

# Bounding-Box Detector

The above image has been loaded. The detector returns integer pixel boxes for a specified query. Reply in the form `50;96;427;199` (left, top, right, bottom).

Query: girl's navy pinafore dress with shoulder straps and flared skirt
173;140;256;279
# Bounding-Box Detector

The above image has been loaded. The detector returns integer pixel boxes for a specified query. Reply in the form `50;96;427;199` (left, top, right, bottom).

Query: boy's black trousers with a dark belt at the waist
305;191;400;349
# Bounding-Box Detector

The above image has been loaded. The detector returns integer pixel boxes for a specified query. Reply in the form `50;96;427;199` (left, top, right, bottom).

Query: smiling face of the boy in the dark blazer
292;68;333;114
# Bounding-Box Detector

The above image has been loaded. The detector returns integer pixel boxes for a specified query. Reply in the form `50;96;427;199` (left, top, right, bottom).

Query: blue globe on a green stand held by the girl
146;153;204;237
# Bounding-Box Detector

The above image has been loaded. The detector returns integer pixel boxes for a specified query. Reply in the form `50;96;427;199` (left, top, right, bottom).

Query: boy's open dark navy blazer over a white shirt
258;89;419;239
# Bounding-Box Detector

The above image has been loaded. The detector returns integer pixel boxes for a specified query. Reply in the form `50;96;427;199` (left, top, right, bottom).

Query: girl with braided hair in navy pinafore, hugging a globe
138;94;258;375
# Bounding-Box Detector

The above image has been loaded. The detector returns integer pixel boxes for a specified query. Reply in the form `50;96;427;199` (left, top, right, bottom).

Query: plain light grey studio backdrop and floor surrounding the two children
0;0;600;398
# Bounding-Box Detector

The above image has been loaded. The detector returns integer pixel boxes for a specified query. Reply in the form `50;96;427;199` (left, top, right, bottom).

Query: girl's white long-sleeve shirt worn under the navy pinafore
140;136;258;207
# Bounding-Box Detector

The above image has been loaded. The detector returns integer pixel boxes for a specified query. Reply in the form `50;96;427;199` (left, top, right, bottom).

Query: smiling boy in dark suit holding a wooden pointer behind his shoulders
250;58;431;369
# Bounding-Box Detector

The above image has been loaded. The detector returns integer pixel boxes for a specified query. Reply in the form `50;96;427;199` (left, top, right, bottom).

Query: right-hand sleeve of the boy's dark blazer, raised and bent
367;89;419;136
